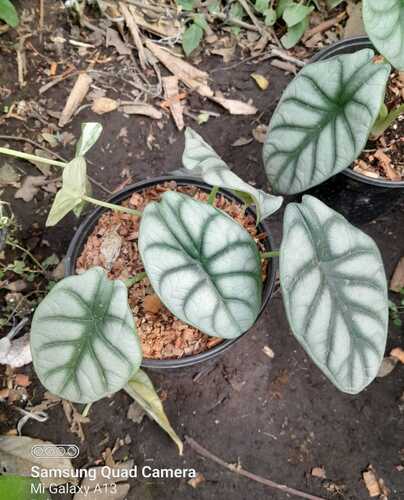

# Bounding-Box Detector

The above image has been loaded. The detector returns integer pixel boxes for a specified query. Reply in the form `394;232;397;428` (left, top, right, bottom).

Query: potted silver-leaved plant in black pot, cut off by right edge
264;0;404;222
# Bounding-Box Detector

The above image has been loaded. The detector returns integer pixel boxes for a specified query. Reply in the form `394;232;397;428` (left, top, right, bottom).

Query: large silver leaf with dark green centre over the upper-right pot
263;49;390;194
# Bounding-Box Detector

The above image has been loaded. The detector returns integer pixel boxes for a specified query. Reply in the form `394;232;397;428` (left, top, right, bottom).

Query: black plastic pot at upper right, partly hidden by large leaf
309;36;404;224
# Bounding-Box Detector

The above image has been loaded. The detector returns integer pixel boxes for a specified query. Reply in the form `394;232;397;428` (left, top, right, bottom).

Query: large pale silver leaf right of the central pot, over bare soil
280;196;388;394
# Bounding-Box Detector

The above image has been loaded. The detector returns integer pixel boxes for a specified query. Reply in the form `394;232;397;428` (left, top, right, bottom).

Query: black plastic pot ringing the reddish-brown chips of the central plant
66;176;276;369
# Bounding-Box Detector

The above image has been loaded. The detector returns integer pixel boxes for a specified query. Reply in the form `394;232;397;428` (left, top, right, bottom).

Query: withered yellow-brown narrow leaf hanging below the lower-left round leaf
125;370;184;455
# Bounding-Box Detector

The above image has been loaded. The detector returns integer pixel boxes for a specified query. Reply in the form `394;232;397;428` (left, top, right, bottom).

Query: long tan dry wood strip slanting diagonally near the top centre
145;40;213;97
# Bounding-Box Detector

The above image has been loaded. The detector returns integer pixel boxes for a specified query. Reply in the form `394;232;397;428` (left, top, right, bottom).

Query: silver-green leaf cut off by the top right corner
363;0;404;70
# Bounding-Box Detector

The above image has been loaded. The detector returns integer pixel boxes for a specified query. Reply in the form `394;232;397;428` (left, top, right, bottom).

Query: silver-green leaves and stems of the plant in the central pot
0;124;388;402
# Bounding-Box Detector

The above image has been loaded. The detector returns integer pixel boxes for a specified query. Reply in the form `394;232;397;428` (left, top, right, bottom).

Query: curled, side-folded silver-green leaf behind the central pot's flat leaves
182;127;283;223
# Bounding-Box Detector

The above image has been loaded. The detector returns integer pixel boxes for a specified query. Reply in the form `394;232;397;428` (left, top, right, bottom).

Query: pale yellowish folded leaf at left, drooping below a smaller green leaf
46;156;88;226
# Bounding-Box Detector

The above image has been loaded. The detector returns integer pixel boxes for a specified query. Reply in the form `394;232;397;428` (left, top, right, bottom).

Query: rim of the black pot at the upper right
310;35;404;189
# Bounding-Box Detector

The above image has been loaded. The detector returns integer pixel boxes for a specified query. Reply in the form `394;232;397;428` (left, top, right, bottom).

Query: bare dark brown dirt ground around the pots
0;1;404;500
